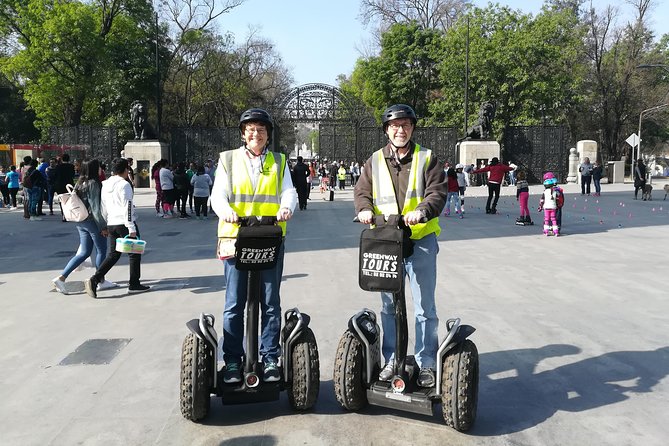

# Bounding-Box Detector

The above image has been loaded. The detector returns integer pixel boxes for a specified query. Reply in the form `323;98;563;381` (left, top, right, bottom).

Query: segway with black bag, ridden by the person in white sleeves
180;217;320;421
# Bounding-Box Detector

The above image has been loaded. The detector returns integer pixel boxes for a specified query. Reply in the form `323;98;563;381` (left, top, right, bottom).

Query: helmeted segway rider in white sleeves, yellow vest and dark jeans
211;108;297;383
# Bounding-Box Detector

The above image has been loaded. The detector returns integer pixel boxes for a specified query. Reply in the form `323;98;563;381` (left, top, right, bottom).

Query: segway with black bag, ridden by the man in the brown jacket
333;216;479;432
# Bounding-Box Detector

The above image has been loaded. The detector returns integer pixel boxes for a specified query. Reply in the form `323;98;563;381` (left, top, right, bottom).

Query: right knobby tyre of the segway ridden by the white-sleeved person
288;328;321;410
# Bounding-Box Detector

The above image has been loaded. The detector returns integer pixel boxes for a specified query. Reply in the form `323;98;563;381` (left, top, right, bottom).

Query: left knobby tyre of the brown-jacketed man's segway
333;330;367;410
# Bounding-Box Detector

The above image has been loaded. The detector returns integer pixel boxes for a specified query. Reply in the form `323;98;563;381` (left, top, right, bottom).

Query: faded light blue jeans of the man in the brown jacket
381;234;439;368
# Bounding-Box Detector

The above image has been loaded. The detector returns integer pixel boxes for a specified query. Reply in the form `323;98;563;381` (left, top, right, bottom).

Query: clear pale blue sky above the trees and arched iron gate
217;0;669;86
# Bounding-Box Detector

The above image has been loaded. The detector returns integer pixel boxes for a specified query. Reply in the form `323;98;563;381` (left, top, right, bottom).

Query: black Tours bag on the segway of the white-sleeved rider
235;219;283;271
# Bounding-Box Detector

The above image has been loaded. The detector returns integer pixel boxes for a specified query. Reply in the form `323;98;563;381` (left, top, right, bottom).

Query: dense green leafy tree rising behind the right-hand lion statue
428;6;582;137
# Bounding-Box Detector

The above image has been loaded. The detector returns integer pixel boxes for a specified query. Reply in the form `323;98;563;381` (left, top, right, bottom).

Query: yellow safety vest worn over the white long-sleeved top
218;148;286;237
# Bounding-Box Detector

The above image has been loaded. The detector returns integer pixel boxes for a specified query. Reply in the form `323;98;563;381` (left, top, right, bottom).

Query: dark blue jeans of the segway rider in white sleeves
223;243;284;363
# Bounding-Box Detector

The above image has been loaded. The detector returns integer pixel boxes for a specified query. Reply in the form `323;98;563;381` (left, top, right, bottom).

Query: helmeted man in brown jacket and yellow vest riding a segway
354;104;446;387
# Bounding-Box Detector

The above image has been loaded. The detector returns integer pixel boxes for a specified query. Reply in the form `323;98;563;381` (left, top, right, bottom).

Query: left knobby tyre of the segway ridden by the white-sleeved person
180;333;214;421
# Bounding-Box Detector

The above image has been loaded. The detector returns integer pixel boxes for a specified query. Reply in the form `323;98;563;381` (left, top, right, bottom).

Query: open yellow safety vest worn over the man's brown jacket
372;144;441;240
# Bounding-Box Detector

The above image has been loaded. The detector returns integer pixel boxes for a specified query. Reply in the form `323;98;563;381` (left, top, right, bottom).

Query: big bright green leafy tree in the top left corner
0;0;159;132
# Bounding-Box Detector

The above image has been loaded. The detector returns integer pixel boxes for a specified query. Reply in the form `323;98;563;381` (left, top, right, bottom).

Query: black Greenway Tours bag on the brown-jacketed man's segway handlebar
358;215;411;293
